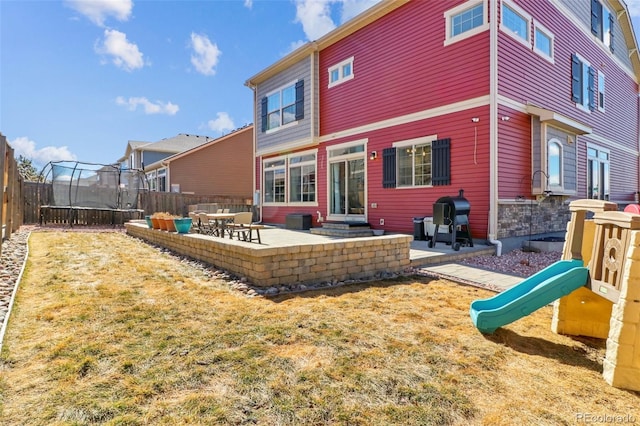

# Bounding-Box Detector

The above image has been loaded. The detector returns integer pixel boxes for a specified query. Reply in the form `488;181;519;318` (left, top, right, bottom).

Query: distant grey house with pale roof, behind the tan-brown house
123;133;212;192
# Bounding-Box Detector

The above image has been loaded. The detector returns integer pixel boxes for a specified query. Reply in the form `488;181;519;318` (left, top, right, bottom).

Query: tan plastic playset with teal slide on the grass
470;200;640;391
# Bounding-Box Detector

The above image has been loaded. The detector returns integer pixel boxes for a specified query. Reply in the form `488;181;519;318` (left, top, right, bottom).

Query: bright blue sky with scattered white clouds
0;0;640;171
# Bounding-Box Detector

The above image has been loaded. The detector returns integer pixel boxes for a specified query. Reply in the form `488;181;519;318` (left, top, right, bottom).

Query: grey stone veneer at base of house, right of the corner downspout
498;196;571;238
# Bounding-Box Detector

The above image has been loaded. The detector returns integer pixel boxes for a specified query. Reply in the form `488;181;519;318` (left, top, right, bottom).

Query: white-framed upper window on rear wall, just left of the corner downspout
444;0;489;46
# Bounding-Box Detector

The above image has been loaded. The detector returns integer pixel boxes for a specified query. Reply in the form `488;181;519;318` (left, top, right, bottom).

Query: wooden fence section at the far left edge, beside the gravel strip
0;133;24;253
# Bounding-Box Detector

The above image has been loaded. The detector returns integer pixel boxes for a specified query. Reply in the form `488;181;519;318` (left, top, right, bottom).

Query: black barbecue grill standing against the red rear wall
429;189;473;251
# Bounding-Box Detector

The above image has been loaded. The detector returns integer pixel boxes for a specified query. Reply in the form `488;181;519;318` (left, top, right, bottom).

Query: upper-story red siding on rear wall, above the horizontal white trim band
319;1;489;135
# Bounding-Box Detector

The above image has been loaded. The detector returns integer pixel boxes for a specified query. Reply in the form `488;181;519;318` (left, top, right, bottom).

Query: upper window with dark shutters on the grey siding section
261;80;304;132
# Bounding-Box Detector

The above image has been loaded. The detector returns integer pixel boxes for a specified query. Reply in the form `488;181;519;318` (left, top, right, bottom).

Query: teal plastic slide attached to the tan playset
470;260;589;334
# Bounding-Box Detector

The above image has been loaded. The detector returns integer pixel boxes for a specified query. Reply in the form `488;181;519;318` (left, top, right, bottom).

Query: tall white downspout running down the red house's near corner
488;0;502;256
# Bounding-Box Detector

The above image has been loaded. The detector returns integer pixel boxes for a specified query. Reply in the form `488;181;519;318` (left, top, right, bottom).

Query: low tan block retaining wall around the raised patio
125;222;413;287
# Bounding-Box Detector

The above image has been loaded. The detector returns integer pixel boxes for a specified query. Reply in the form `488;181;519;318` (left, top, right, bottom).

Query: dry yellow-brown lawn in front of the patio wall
0;232;640;425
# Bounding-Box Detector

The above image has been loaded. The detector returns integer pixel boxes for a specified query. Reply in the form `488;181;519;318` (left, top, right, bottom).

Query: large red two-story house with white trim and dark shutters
246;0;640;250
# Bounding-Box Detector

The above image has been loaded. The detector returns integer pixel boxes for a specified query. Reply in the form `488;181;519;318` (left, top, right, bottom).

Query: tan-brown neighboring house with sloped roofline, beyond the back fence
161;124;254;199
